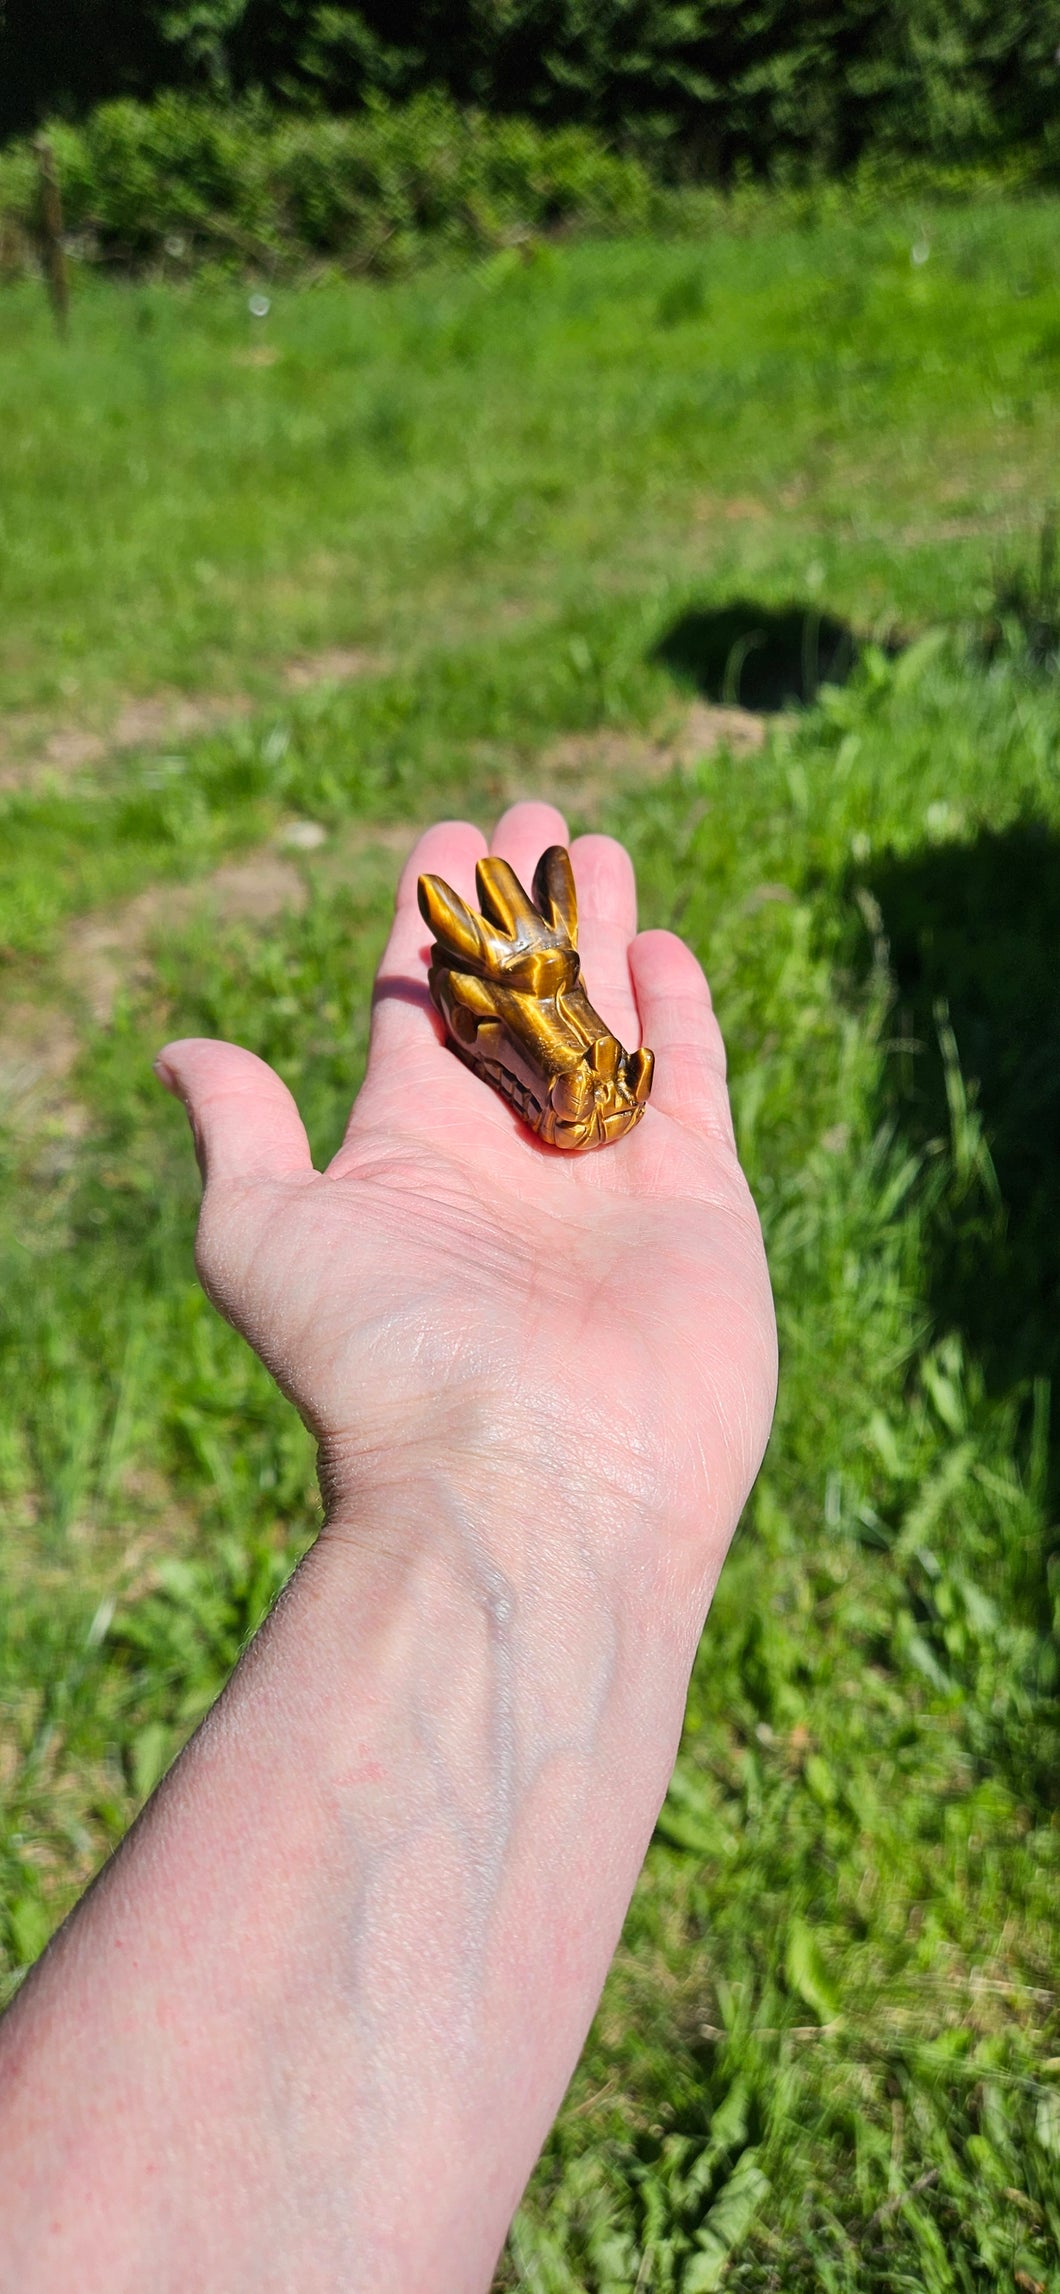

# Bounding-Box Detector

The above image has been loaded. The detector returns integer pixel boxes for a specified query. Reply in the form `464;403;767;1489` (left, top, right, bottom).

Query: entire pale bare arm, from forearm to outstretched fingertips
0;803;775;2294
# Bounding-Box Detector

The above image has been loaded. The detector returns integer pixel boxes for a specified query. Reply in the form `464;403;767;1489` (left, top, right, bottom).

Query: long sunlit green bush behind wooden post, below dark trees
0;92;652;266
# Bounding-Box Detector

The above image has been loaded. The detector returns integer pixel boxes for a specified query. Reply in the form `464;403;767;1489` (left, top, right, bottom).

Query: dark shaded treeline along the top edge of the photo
0;0;1060;181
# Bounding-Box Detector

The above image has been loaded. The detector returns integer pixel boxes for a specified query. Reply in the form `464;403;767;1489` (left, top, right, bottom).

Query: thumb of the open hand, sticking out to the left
154;1035;312;1184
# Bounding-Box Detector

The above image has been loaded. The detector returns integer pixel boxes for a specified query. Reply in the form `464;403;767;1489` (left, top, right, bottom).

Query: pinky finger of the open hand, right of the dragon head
629;931;732;1145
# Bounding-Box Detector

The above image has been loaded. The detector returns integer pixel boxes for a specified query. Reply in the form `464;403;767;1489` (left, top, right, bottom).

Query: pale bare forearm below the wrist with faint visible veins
0;1475;695;2294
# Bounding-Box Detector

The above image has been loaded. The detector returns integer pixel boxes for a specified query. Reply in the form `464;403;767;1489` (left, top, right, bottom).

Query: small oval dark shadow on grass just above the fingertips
652;596;858;713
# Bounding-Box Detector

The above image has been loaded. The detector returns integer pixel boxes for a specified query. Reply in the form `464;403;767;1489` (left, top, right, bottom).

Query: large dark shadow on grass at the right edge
870;819;1060;1431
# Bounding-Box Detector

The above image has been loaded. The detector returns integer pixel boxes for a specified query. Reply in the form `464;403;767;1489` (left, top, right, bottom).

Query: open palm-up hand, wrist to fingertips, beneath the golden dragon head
158;803;775;1629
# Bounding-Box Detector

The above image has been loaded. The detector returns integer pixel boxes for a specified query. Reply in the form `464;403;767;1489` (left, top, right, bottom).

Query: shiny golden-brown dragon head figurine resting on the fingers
418;844;654;1149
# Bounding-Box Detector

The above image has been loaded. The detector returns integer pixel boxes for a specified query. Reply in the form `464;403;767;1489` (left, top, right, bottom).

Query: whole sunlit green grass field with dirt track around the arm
0;200;1060;2294
